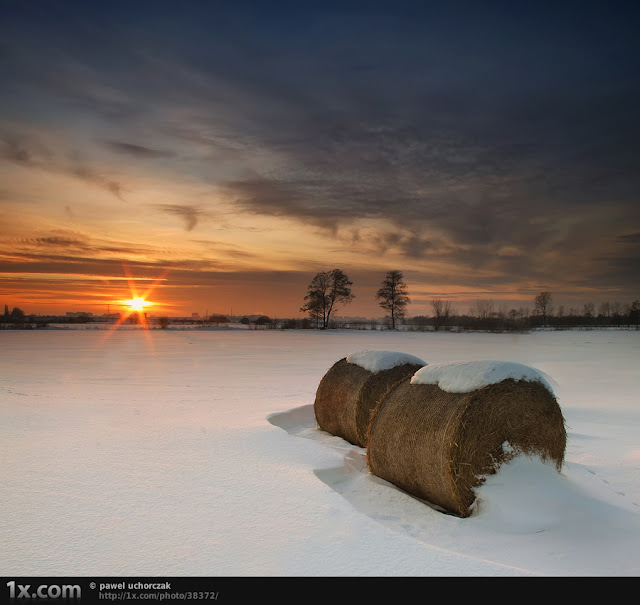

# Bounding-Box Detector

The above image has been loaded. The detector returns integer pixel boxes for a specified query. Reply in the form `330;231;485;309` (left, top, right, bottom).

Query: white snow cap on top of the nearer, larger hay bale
411;359;553;394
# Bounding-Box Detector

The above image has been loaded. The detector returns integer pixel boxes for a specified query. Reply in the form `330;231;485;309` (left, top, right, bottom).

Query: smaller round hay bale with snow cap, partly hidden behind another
313;351;426;447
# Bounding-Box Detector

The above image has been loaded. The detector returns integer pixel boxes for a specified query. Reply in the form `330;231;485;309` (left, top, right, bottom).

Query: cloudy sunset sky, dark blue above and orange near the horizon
0;0;640;317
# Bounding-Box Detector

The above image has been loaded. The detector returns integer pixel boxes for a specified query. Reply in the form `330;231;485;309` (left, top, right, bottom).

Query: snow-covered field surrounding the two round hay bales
0;329;640;577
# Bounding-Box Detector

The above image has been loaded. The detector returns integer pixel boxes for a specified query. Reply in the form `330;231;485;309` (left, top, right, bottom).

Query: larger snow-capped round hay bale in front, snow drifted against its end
367;361;567;517
